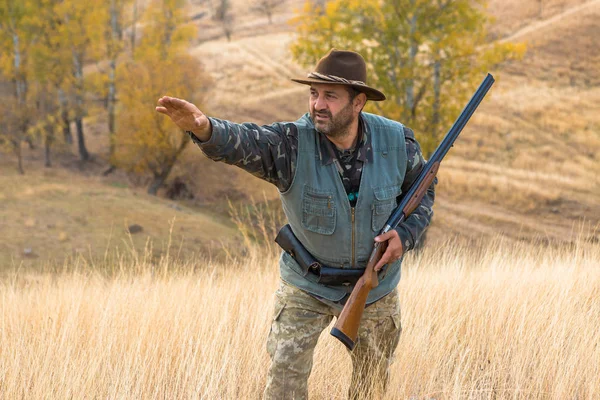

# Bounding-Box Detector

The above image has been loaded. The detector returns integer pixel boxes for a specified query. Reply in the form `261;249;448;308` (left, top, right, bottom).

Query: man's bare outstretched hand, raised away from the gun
156;96;212;141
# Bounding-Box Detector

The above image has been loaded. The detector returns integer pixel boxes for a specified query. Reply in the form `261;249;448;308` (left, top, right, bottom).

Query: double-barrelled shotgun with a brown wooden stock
331;74;494;350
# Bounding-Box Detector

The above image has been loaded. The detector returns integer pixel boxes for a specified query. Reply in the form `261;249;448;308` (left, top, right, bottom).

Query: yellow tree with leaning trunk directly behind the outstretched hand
113;0;206;194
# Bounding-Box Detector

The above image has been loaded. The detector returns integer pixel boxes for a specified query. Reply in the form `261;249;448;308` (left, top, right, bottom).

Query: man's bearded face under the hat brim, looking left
309;83;360;138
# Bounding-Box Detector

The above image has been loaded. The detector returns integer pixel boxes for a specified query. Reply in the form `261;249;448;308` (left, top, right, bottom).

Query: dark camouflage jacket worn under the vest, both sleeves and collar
187;112;437;251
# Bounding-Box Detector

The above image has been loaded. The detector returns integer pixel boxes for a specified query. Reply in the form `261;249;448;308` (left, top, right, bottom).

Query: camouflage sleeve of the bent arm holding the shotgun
396;127;437;252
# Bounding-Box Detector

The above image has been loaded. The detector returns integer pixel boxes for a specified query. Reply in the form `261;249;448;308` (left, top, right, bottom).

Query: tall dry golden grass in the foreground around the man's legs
0;234;600;399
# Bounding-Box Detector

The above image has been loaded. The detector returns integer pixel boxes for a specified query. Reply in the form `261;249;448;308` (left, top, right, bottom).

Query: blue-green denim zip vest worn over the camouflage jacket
279;113;407;304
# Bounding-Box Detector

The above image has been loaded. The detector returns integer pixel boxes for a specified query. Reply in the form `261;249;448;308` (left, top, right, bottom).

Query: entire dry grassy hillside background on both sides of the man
0;0;600;264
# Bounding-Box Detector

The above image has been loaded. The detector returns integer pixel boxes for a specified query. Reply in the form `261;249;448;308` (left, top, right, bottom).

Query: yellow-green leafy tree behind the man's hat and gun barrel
291;0;525;154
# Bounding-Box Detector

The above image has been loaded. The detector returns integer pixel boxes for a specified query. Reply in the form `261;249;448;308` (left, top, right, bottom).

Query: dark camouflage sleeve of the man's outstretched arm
188;118;298;192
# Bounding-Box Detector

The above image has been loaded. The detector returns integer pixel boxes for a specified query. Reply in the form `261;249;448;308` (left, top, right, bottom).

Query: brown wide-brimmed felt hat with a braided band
292;49;385;101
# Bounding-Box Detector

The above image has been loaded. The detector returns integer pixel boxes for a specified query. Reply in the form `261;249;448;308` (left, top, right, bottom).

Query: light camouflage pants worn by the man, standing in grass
265;281;402;400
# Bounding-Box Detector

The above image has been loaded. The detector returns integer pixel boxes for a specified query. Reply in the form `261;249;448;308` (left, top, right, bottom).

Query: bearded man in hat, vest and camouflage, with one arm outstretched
156;49;434;399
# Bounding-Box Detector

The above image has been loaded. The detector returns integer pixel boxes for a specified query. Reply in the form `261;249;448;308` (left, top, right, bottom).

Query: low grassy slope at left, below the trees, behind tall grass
0;164;236;271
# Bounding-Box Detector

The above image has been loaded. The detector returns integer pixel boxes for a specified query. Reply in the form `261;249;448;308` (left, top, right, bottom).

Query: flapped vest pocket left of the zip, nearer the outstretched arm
302;186;336;235
